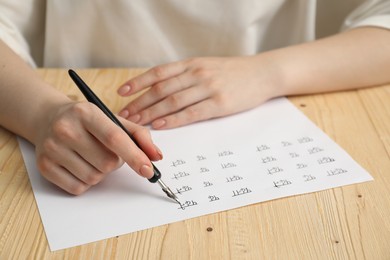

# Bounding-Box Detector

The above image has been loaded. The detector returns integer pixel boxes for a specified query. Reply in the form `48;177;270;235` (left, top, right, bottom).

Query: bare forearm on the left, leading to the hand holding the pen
0;40;69;142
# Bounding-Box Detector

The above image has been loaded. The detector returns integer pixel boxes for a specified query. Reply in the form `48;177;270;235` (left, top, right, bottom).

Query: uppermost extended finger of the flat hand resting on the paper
118;61;187;96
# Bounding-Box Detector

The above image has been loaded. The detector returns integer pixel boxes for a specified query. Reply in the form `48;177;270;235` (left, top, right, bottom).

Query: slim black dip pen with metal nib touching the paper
68;70;181;205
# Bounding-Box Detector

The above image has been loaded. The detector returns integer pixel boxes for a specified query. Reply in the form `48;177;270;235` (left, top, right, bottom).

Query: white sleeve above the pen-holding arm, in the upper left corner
0;0;45;67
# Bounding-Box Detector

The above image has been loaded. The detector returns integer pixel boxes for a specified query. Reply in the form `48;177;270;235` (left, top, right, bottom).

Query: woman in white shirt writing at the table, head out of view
0;0;390;194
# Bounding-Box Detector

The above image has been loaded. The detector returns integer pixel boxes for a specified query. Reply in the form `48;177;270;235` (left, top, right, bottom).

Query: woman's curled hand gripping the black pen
34;102;162;195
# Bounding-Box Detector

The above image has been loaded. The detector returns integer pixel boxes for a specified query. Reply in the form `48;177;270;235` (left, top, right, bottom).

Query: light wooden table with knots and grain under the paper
0;69;390;259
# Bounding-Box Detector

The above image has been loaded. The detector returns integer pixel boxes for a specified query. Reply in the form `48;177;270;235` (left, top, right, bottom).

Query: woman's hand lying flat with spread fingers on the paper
118;56;278;129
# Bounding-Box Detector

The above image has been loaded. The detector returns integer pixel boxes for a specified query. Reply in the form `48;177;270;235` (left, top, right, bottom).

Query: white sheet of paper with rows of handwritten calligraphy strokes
20;98;372;250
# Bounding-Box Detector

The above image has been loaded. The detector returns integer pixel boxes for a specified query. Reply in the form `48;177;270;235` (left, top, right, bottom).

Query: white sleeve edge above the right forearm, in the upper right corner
342;0;390;30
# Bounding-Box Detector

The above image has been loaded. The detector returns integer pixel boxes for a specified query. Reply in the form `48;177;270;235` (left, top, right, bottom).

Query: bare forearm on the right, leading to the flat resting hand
256;27;390;96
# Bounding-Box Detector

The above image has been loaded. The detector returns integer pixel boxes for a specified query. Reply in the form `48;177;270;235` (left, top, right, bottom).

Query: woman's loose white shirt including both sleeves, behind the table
0;0;390;68
